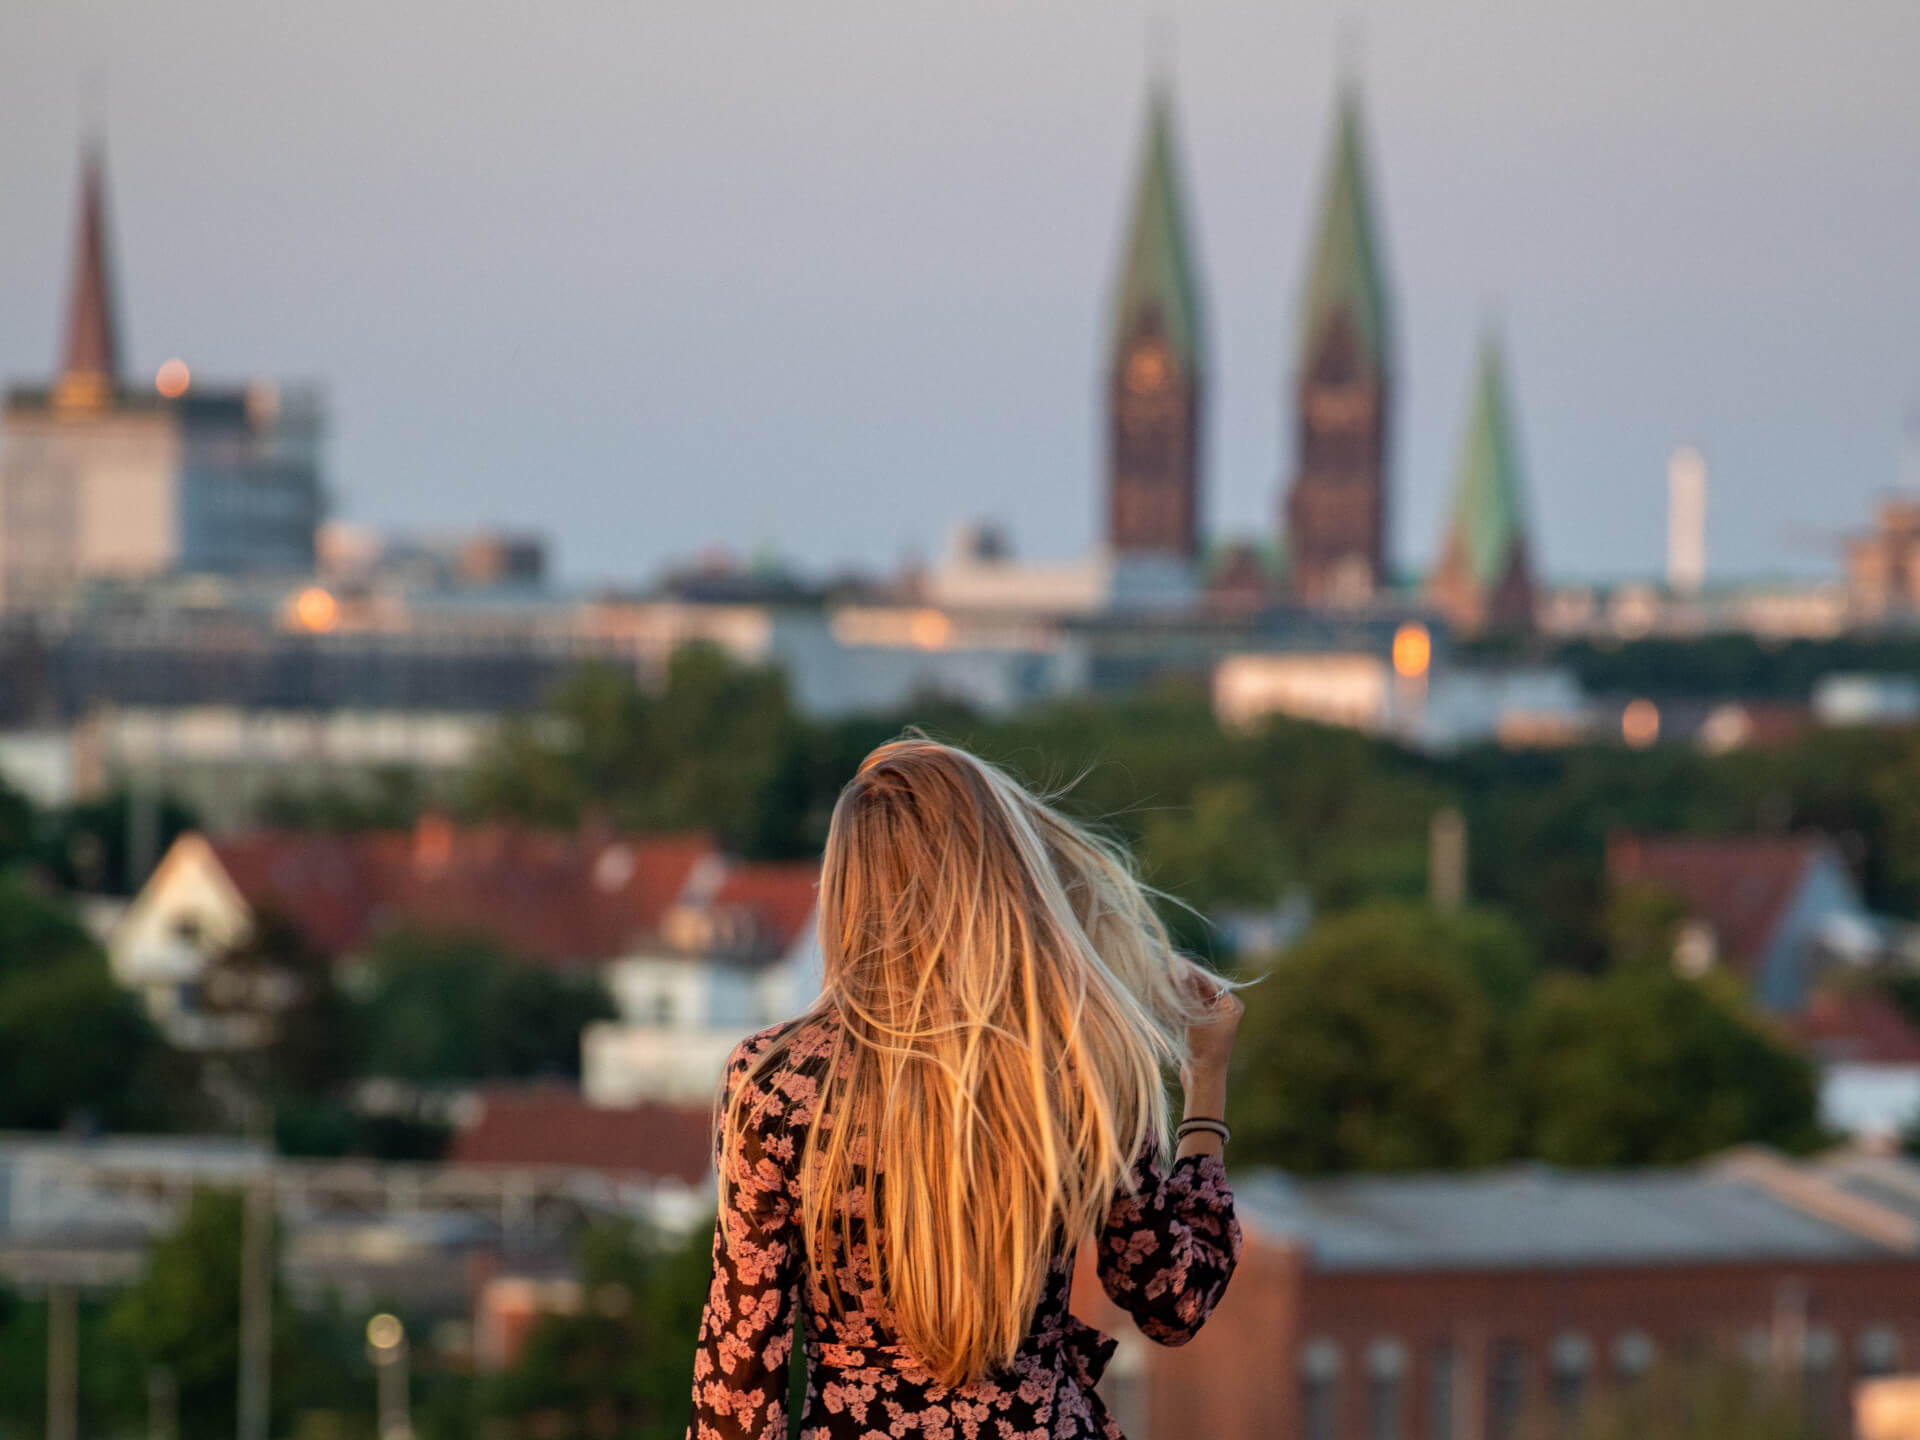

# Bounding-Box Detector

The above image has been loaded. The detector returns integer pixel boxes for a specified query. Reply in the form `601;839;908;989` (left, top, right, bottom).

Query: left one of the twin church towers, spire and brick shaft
1106;83;1202;561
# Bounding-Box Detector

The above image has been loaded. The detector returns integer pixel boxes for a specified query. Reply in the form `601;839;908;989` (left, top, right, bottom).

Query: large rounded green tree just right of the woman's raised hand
1231;904;1513;1173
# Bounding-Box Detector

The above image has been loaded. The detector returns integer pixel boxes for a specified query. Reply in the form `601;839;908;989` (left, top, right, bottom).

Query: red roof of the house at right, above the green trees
1607;833;1826;973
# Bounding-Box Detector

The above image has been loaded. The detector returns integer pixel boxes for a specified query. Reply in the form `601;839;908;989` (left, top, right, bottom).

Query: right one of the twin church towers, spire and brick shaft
1284;86;1392;605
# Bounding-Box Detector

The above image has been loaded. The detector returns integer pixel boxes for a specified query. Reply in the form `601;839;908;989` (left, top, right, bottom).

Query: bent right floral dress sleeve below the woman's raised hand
1098;1144;1240;1346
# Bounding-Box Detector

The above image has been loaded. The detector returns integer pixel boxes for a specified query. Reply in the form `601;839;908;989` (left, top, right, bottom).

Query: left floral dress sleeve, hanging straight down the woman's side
687;1052;801;1440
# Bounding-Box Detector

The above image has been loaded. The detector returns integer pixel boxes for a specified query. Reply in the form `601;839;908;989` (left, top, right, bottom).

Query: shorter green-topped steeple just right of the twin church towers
1430;334;1534;630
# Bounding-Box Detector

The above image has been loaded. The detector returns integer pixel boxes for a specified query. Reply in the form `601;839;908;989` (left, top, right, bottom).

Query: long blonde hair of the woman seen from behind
722;737;1200;1384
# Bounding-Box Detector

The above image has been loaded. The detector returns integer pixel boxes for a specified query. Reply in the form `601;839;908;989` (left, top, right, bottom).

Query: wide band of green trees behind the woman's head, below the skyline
435;647;1920;970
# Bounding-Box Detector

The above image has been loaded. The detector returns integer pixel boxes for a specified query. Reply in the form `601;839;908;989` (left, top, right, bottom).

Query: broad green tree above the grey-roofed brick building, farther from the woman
1515;970;1820;1165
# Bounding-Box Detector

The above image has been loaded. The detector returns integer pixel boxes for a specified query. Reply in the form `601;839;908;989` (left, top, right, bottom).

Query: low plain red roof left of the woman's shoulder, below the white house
445;1083;712;1185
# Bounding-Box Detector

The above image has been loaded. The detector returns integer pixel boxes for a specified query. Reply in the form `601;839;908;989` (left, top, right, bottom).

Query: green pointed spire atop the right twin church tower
1296;81;1392;374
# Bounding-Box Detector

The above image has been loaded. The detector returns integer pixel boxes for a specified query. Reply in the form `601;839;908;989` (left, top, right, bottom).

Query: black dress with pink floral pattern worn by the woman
687;1020;1240;1440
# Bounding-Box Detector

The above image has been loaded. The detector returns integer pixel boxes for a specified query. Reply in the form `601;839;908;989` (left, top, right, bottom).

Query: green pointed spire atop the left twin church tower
1112;81;1204;376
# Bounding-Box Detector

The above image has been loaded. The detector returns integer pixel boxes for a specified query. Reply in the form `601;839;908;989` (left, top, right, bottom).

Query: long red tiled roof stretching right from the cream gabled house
209;818;716;964
